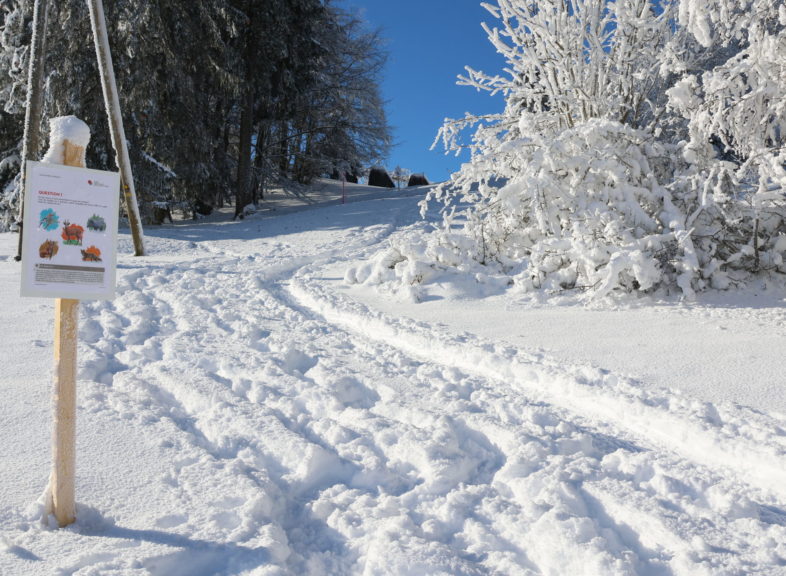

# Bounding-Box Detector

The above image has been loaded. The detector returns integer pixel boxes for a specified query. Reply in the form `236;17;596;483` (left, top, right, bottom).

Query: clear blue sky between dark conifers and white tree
338;0;505;182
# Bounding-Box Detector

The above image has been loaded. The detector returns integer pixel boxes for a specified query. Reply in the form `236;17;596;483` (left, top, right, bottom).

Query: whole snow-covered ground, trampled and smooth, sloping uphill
0;184;786;576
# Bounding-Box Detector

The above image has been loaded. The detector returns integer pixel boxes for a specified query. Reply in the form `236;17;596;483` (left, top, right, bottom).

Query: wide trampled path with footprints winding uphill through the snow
0;195;786;576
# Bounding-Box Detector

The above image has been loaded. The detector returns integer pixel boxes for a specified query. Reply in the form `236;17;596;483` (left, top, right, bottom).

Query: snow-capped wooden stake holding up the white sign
44;116;90;527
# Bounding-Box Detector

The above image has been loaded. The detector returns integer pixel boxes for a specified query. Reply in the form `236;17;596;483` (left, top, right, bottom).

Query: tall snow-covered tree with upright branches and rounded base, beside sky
416;0;695;292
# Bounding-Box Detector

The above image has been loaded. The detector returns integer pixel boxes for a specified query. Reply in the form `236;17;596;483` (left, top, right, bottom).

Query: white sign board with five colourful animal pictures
21;162;120;300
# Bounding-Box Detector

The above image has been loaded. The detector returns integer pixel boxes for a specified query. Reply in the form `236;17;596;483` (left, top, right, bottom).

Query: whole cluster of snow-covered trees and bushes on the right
349;0;786;297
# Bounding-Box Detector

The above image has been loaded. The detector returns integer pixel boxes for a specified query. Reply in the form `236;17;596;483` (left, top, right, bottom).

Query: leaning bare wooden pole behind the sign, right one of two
87;0;145;256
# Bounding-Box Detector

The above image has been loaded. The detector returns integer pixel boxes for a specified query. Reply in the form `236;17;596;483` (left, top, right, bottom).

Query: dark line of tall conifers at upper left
0;0;390;224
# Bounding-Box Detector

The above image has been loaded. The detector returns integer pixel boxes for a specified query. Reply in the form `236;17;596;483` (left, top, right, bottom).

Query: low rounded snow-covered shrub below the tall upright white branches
414;119;699;294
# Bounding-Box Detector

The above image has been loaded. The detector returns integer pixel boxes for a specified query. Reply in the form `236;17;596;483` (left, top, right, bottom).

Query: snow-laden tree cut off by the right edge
666;0;786;280
